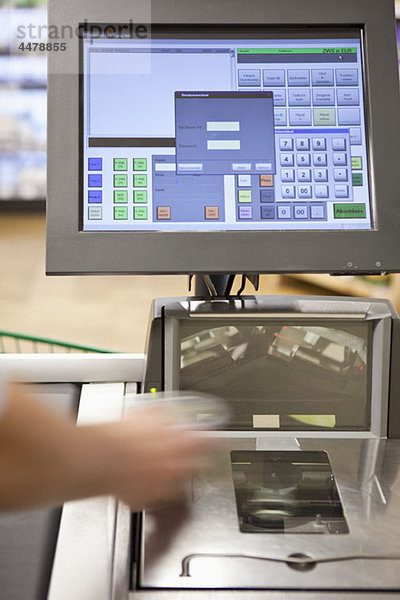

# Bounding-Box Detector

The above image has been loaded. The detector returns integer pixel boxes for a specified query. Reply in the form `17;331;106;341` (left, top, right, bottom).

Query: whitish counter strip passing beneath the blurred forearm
48;383;130;600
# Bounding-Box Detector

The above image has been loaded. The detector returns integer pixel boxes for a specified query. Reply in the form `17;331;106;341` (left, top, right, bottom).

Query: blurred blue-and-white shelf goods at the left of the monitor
0;0;47;203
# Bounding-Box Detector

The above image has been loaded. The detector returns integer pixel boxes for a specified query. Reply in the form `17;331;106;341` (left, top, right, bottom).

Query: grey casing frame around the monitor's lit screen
47;0;400;274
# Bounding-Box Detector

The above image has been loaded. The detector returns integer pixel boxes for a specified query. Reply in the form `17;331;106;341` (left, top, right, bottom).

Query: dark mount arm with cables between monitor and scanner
189;274;260;298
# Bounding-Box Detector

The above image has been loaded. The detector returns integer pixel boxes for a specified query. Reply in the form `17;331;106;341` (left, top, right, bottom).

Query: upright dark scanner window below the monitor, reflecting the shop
178;317;372;431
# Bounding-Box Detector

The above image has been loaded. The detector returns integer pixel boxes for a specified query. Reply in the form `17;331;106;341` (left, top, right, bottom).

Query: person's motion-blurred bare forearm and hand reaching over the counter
0;385;207;510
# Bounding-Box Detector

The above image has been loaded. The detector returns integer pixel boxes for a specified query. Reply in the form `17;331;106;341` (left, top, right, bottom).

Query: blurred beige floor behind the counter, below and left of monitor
0;213;318;352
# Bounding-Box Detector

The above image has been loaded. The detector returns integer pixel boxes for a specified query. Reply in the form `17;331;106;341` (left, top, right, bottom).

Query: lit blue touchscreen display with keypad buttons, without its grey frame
80;29;376;232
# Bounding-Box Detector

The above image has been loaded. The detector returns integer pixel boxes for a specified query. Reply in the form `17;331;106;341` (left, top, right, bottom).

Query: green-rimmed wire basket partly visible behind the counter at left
0;330;113;354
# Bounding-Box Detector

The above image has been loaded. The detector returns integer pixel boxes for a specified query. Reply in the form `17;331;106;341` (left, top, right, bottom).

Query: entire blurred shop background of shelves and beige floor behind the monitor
0;0;400;352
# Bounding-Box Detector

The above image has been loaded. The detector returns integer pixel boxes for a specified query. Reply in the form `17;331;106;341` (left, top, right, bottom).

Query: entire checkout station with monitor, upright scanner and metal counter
2;0;400;600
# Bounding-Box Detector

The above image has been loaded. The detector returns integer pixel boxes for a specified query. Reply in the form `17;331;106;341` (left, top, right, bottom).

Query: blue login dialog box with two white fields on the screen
175;92;275;175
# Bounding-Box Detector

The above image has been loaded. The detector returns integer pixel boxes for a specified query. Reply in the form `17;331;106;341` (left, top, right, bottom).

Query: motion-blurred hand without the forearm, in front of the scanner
94;406;213;510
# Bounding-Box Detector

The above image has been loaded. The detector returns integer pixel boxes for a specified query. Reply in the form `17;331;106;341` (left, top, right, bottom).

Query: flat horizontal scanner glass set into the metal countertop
231;451;349;534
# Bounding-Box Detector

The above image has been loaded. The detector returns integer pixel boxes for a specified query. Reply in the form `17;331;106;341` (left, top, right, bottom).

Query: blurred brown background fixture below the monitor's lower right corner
290;273;400;310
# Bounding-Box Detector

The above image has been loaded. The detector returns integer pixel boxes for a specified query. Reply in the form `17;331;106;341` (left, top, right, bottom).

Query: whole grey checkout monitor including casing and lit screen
47;0;400;274
